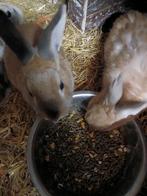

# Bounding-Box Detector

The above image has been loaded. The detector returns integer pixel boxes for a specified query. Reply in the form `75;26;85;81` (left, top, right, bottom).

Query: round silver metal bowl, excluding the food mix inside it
27;91;147;196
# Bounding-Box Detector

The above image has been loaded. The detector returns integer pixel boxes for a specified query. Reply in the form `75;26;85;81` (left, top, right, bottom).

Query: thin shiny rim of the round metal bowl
26;91;147;196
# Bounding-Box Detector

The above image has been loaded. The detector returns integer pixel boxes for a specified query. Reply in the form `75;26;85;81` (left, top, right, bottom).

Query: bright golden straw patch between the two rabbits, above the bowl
63;20;101;90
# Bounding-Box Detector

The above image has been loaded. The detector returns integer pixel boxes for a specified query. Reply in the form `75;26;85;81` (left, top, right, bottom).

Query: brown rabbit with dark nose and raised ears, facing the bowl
0;4;74;122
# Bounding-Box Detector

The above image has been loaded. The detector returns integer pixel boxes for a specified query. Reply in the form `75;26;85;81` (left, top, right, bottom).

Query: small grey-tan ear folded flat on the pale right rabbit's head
108;74;123;105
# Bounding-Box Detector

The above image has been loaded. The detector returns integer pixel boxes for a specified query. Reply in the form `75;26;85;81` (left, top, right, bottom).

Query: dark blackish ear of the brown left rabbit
0;10;33;64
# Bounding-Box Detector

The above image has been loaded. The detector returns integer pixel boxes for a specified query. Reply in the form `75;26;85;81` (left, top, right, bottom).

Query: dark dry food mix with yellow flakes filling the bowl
36;112;129;195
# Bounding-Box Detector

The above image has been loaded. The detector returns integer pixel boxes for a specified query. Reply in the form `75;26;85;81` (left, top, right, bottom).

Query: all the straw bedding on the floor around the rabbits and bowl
0;0;147;196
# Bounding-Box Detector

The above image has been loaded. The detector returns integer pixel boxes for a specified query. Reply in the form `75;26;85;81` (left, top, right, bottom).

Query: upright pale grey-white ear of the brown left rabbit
38;4;67;59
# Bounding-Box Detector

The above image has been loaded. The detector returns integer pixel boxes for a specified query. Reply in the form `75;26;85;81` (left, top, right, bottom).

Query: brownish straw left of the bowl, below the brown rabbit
0;91;37;196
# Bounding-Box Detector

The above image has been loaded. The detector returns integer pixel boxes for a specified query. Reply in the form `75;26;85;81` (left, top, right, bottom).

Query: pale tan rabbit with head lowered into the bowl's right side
85;11;147;130
